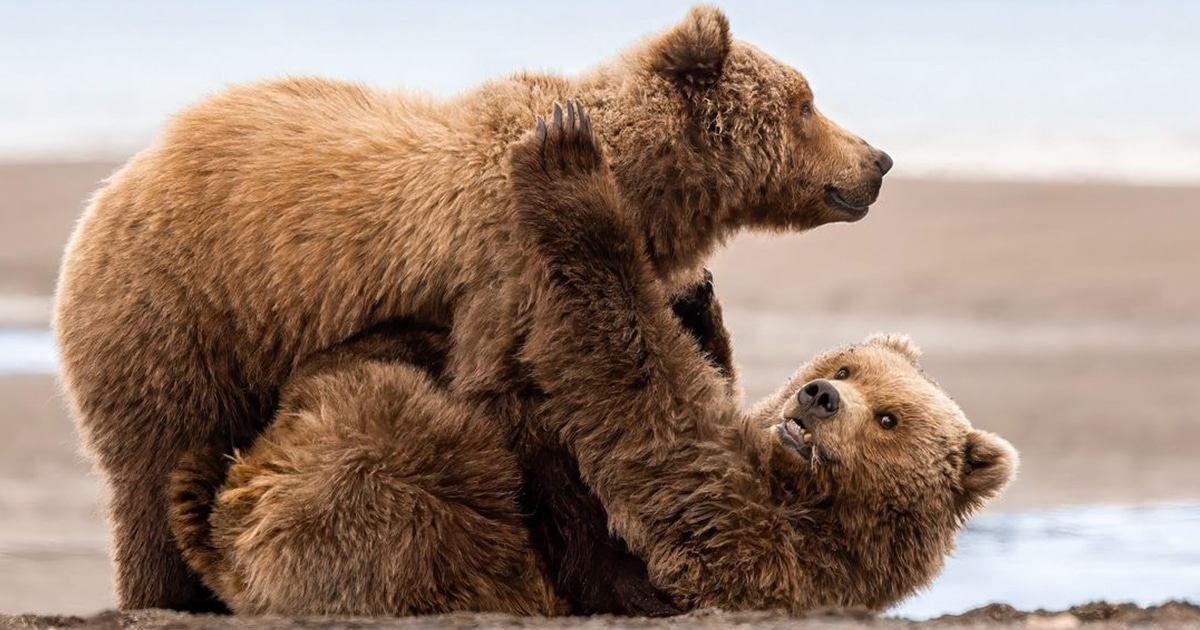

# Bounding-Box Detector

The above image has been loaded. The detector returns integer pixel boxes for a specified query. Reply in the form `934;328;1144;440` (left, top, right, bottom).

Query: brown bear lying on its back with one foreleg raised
170;114;1016;614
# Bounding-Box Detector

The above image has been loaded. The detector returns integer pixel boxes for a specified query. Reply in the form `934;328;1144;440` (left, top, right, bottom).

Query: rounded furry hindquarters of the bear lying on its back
170;321;564;616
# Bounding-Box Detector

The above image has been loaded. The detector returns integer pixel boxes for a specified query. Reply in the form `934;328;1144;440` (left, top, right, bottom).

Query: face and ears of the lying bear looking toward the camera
770;335;1018;527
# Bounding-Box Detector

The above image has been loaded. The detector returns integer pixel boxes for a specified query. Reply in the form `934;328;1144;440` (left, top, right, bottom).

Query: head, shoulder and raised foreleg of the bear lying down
512;103;1016;612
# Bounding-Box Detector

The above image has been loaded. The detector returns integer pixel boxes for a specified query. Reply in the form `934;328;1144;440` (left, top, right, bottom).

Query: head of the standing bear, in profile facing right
595;6;892;270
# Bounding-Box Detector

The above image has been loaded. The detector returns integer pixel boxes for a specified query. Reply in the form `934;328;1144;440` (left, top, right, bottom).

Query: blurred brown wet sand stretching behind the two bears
0;164;1200;614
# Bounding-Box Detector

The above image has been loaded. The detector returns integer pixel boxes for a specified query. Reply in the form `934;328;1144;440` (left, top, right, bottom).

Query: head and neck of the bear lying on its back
757;335;1018;610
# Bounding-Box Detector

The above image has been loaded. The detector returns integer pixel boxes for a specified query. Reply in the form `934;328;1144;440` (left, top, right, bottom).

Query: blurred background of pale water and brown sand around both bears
0;0;1200;617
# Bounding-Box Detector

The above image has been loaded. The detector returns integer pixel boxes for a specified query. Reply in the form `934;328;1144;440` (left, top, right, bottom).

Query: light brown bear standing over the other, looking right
54;6;892;610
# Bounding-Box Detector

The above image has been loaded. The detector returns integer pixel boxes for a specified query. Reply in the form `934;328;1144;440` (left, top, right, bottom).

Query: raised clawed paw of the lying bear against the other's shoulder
514;100;604;180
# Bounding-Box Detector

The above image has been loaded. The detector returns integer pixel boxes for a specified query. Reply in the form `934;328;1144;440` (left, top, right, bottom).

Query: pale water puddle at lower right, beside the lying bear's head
888;504;1200;619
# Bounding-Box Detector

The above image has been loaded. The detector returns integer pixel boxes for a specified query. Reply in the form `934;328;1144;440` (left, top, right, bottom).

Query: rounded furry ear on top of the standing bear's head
650;5;733;94
